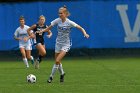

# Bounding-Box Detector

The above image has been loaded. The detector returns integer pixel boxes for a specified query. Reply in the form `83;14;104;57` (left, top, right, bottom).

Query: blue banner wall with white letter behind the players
0;0;140;60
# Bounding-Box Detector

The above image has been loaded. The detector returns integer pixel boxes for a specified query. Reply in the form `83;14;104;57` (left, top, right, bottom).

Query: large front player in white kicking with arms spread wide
41;6;89;83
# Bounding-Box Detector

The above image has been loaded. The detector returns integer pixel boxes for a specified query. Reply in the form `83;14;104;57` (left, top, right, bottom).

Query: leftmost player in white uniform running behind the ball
14;16;34;68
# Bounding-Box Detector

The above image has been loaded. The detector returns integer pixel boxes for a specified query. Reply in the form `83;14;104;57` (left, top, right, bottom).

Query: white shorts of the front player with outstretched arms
55;43;71;53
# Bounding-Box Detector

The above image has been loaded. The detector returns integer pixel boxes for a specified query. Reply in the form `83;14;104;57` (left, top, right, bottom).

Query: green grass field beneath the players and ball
0;58;140;93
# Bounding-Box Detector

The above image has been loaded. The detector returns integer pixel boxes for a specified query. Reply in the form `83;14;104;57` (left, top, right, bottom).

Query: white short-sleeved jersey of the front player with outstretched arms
51;18;77;45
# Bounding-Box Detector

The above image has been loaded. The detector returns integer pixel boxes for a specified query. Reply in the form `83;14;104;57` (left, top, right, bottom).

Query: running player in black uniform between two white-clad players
28;15;52;69
